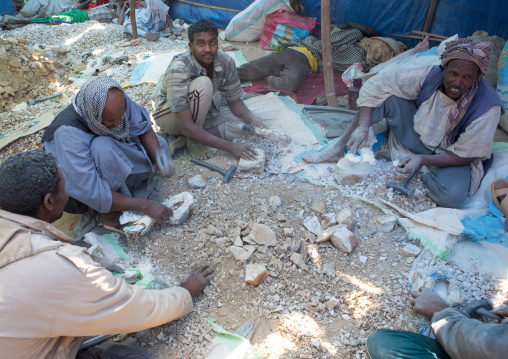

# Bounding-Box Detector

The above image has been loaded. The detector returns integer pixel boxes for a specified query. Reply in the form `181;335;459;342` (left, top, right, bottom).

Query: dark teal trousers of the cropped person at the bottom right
367;329;450;359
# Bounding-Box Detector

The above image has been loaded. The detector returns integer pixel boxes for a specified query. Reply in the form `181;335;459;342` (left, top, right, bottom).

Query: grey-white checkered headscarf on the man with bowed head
72;76;130;141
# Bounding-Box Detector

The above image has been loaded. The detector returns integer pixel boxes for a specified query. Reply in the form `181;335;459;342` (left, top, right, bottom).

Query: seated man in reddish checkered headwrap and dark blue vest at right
303;39;503;208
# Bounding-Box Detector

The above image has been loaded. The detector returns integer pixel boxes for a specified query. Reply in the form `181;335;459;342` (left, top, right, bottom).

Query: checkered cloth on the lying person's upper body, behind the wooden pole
299;28;370;71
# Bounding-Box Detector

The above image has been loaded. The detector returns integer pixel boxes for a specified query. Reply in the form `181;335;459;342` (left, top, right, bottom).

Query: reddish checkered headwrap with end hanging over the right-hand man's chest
441;39;492;133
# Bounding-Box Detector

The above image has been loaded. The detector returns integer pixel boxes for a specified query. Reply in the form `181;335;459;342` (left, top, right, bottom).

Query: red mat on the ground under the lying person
243;70;347;105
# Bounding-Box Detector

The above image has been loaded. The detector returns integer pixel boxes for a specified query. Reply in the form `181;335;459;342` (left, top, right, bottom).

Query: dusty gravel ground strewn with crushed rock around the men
0;22;507;359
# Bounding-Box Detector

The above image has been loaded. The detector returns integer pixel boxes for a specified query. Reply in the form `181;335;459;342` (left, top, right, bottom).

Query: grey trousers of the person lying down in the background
238;49;312;92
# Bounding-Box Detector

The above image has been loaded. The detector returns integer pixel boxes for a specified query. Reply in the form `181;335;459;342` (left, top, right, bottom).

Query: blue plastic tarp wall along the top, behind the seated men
171;0;508;41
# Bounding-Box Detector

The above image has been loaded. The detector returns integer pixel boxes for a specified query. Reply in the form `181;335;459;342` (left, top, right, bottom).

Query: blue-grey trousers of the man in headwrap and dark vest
370;96;471;208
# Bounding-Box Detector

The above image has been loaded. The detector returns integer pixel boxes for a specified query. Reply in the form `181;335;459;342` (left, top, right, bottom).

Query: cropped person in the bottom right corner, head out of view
367;288;508;359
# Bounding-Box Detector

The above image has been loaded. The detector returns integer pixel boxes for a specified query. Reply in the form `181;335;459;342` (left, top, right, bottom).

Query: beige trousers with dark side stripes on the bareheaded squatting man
153;76;245;141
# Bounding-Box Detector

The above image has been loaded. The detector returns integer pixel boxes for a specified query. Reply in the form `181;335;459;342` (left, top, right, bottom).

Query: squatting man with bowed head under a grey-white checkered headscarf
42;76;175;225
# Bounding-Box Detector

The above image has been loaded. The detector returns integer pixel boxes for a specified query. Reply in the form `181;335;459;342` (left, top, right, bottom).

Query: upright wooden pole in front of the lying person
321;0;338;107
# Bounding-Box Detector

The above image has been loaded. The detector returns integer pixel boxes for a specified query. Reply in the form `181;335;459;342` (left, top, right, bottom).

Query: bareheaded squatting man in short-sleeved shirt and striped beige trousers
152;20;266;160
